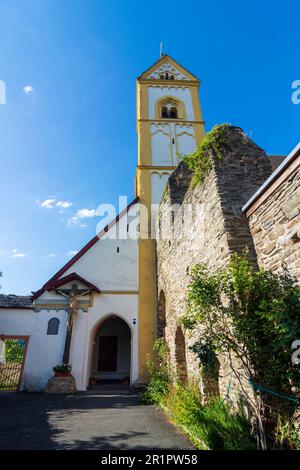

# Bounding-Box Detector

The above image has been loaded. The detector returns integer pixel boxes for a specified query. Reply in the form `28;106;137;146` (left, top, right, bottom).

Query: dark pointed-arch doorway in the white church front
91;315;131;383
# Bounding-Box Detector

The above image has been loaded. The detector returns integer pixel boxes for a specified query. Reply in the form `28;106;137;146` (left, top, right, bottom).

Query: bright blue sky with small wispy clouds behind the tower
0;0;300;294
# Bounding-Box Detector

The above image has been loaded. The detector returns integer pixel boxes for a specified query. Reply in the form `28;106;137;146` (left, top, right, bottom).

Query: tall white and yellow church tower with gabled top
136;54;204;381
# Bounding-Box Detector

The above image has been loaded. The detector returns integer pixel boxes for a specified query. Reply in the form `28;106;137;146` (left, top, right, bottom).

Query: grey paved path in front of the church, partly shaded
0;390;192;450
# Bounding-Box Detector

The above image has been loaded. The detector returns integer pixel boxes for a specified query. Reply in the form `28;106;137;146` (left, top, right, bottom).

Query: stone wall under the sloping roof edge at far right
245;151;300;286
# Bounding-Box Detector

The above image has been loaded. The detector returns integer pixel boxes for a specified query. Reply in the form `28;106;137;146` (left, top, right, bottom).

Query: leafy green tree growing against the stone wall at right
181;253;300;448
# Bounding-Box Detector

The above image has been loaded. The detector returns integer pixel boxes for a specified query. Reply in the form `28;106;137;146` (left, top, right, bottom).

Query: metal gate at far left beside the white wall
0;335;29;392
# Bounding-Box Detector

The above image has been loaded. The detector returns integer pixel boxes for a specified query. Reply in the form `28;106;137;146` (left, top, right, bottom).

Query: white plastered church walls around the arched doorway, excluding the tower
0;204;138;391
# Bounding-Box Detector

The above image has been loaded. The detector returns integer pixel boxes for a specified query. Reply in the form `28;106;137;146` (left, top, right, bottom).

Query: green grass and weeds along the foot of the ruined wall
141;340;256;450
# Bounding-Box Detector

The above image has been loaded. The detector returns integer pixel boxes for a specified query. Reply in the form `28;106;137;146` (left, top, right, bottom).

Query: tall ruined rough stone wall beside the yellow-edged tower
157;126;271;404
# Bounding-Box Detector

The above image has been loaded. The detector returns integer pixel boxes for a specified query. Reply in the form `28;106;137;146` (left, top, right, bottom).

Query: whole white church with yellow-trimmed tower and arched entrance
0;55;204;391
